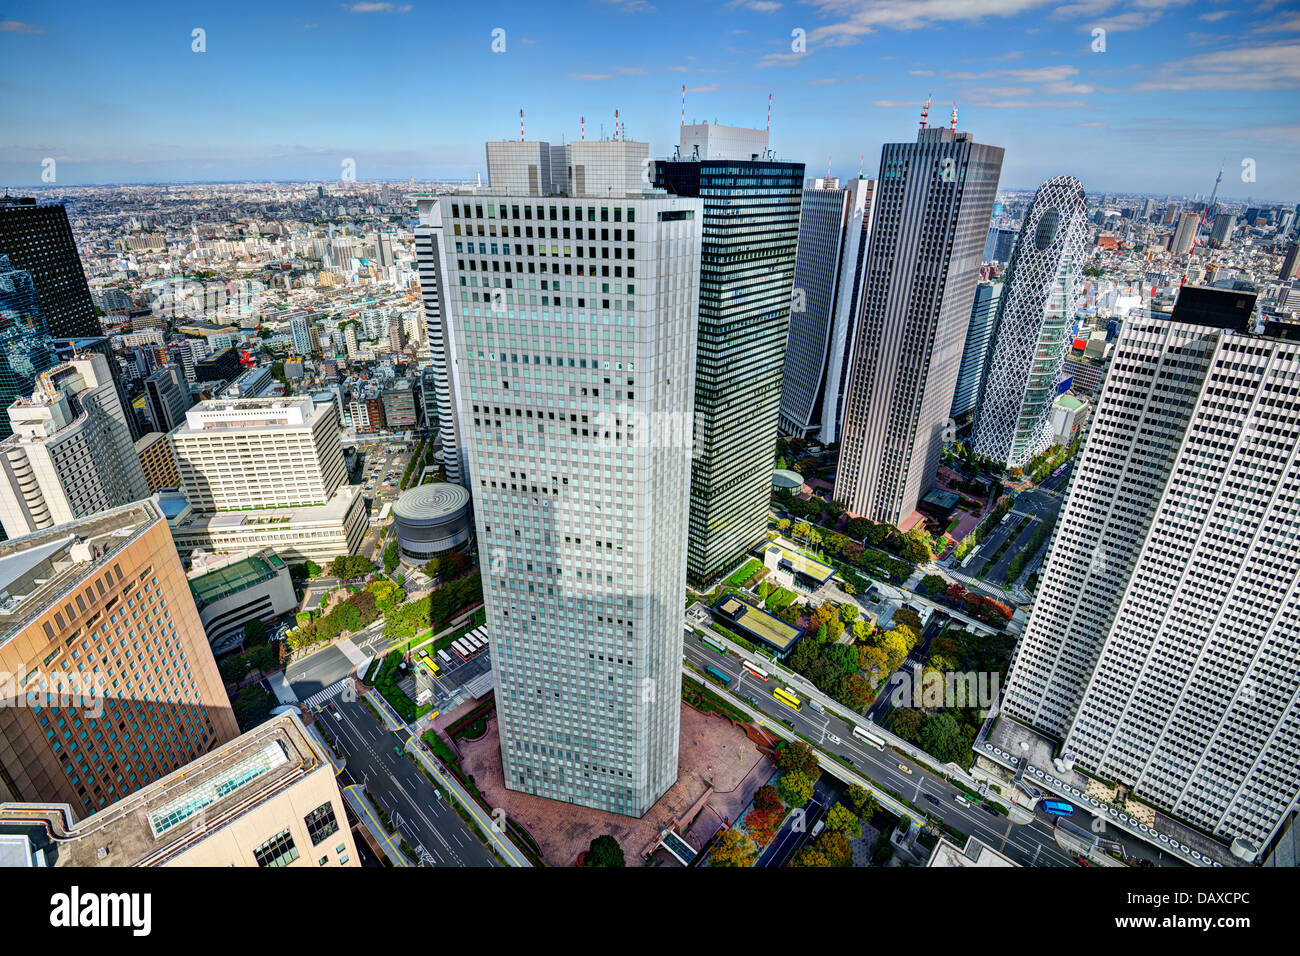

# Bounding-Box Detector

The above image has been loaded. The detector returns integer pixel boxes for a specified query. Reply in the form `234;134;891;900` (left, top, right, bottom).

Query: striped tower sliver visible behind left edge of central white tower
415;196;465;485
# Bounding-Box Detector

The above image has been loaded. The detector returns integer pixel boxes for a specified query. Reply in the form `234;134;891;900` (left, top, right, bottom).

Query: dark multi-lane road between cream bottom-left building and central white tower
319;696;501;866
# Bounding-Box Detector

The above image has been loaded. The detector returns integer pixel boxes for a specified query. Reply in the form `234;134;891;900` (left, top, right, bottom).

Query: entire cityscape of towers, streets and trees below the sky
0;85;1300;869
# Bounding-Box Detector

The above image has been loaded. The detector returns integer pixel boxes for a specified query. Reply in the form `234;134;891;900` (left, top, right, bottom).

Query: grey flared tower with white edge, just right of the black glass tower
780;179;876;444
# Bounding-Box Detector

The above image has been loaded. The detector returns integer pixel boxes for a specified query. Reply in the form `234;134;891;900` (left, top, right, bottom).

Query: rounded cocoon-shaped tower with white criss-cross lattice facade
975;176;1088;468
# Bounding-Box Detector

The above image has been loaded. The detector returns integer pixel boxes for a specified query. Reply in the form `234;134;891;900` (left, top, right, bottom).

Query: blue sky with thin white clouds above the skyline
0;0;1300;202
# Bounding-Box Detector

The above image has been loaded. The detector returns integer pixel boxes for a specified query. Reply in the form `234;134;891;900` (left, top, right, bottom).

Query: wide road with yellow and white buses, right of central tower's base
684;636;1075;866
